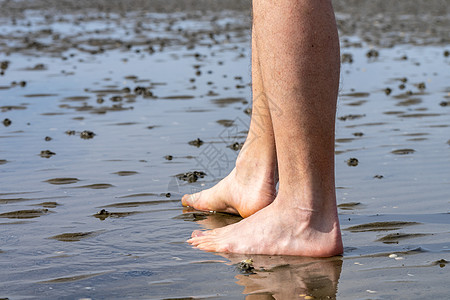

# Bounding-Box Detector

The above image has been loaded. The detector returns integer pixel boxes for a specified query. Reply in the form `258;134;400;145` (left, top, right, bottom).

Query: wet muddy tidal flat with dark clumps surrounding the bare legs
0;0;450;299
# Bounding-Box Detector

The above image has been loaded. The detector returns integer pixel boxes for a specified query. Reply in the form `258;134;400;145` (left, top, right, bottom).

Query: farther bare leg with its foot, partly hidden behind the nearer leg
182;25;278;217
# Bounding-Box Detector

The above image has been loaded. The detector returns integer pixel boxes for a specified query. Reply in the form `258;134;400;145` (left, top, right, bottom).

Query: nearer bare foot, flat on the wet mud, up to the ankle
188;195;343;257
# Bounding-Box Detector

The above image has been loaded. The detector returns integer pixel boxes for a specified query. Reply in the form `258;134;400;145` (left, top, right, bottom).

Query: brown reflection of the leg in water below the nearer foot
223;254;342;299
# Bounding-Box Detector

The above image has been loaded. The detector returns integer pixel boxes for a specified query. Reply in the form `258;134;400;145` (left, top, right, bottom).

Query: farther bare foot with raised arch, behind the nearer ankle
181;149;278;218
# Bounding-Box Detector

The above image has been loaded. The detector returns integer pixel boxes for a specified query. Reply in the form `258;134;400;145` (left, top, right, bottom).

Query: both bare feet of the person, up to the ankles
182;144;343;257
